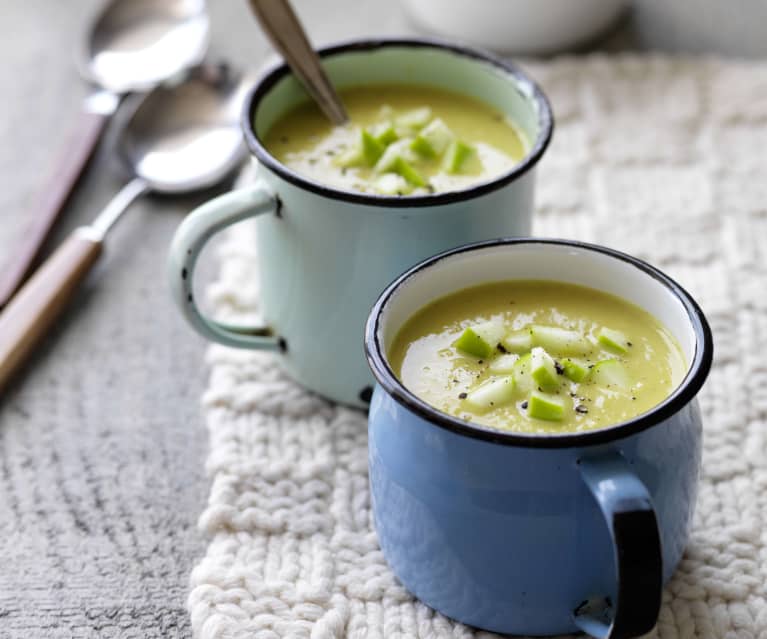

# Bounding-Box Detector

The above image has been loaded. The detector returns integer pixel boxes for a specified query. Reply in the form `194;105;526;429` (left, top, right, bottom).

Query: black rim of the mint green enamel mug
241;38;554;208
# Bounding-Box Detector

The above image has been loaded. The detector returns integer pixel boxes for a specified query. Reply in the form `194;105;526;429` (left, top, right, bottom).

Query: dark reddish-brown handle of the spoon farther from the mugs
0;112;108;309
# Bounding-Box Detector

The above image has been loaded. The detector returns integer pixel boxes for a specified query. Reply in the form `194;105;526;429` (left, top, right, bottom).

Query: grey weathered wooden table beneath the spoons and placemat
0;0;760;639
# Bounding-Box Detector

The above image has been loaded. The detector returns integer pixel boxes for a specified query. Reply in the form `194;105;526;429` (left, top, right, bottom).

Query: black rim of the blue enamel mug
365;238;714;448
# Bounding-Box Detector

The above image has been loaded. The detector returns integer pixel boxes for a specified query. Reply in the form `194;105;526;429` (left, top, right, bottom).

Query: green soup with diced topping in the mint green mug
264;85;529;196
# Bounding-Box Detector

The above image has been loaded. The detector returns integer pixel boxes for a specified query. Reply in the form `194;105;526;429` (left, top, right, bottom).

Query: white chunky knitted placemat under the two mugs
189;57;767;639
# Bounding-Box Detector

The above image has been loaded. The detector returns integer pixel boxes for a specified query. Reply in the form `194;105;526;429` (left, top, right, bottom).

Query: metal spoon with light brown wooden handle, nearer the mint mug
0;66;250;396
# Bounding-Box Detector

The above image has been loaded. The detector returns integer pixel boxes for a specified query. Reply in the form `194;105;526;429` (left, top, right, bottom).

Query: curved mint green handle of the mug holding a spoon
168;182;286;351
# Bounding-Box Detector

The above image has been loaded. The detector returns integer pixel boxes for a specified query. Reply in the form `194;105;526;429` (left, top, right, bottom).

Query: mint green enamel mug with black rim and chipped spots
169;40;553;406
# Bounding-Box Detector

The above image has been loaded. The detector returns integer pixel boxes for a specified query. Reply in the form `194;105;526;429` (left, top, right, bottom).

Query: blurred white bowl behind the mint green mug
402;0;625;54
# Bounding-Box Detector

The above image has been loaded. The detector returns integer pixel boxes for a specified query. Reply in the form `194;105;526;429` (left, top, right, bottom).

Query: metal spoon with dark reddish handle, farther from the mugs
0;0;208;308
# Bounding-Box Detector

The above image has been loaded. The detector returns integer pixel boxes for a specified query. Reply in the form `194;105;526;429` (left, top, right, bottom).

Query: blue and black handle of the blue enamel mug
573;451;663;639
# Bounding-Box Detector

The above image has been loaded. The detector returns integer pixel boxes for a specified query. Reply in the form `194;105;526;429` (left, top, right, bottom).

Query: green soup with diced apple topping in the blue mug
389;280;687;433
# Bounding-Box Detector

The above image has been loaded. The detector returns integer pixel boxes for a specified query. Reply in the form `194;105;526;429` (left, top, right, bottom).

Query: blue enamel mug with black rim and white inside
365;239;713;639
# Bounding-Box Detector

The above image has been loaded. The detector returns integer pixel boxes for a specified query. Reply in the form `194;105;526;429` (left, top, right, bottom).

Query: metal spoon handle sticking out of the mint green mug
250;0;349;124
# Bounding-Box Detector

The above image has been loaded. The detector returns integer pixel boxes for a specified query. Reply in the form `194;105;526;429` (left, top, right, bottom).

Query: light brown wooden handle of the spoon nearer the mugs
0;227;102;389
